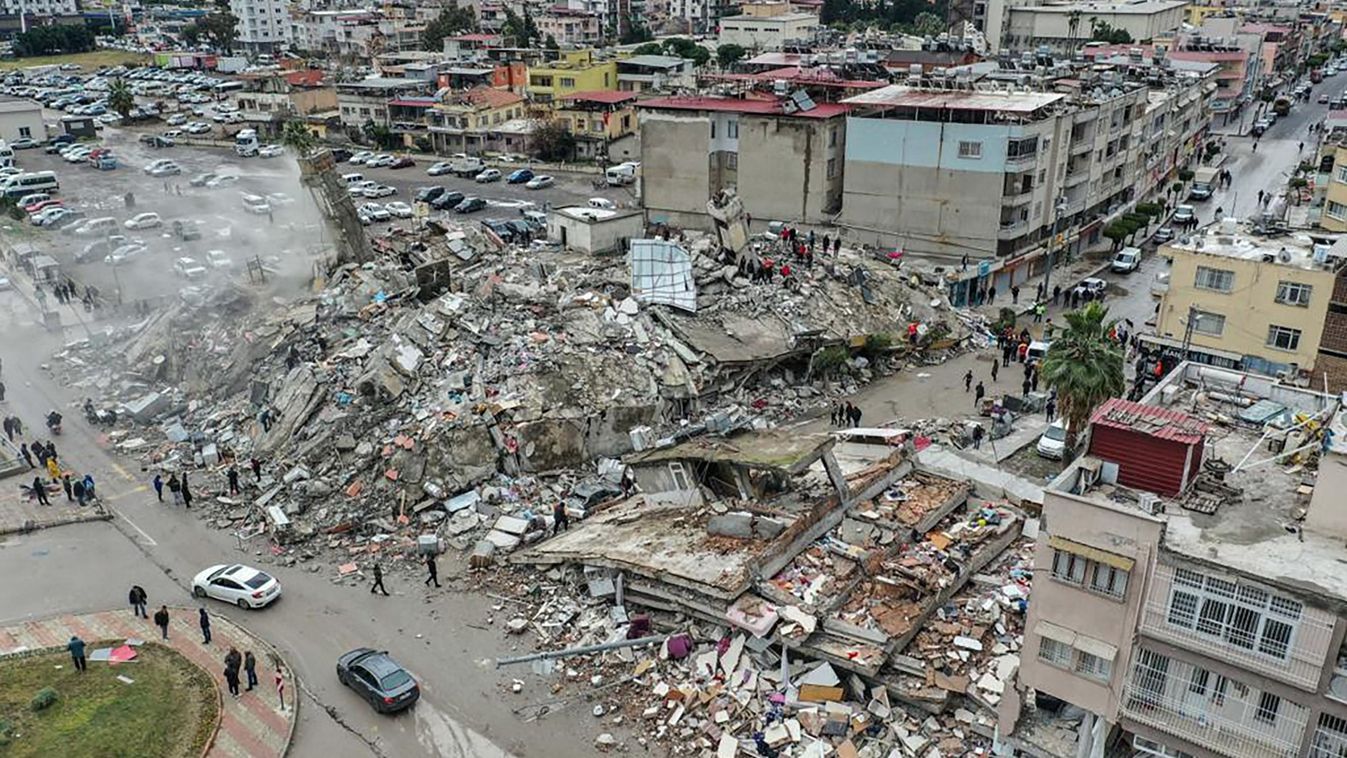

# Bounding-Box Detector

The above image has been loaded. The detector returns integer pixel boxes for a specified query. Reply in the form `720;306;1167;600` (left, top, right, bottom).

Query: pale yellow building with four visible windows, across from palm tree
1156;219;1347;376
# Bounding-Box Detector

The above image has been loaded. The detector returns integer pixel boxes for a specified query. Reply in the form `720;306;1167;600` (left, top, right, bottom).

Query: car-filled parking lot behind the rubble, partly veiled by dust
9;125;634;303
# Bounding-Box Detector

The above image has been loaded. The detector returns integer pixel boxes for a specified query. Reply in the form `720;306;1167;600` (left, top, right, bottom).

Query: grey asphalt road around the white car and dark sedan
0;307;614;758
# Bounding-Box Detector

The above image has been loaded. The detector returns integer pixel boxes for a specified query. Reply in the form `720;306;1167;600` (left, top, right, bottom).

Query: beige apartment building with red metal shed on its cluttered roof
999;364;1347;758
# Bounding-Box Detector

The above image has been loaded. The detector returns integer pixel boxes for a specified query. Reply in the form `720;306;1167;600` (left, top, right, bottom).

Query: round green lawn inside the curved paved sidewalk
0;641;220;758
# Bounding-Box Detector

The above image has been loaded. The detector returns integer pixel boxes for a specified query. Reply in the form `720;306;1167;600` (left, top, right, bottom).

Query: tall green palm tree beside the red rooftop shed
1041;303;1126;448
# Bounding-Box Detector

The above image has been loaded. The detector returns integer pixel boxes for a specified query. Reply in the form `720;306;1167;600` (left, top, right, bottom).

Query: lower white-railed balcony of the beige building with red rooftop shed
1119;649;1309;758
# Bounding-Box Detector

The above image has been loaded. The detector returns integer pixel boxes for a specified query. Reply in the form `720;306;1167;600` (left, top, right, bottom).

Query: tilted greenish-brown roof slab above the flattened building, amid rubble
628;429;834;474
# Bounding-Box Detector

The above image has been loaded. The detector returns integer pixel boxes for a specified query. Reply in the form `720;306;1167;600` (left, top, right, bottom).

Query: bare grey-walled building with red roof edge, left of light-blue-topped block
636;96;850;229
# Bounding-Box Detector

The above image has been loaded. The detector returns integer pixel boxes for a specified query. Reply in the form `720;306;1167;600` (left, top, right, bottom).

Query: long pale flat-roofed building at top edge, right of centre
998;0;1188;55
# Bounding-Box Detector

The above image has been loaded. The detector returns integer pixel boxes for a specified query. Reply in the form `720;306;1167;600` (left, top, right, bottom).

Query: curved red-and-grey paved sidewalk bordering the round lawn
0;606;298;758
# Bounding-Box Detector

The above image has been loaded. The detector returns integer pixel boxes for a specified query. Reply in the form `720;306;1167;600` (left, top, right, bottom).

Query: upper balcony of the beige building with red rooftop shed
1141;565;1335;692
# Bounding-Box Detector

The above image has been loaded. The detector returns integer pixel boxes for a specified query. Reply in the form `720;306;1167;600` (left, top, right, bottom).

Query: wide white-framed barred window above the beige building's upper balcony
1167;568;1301;661
